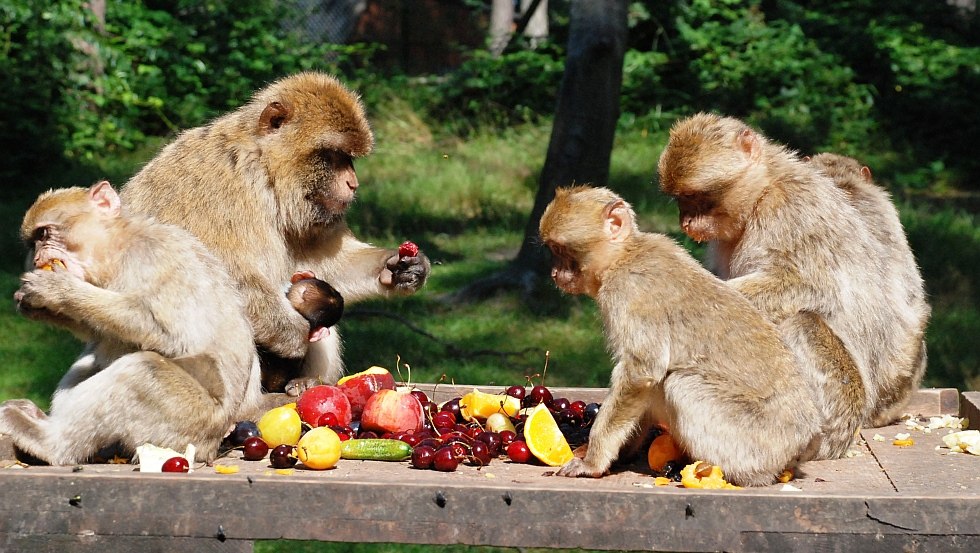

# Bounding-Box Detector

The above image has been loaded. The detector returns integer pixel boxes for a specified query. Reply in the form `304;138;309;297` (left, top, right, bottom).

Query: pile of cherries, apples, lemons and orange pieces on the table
209;367;599;472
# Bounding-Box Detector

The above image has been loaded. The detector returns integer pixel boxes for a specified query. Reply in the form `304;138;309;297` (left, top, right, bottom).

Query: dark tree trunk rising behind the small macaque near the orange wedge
455;0;627;301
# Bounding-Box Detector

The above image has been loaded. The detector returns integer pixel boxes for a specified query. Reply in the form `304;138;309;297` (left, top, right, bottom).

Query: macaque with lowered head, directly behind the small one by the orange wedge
658;113;928;450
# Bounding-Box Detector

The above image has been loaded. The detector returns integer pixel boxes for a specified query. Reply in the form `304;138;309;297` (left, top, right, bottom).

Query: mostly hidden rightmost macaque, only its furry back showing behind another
810;153;930;426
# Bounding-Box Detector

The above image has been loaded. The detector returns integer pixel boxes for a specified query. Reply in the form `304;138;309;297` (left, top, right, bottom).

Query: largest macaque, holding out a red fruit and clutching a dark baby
122;73;429;395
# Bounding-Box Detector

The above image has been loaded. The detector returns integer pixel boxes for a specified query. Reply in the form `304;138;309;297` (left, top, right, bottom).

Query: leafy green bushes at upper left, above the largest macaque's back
0;0;373;172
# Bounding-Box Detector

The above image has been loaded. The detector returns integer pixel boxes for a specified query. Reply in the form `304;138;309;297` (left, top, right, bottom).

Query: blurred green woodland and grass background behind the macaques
0;0;980;406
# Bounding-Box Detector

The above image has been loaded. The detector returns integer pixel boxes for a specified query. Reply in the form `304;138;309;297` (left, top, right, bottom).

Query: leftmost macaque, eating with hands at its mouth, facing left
0;181;268;465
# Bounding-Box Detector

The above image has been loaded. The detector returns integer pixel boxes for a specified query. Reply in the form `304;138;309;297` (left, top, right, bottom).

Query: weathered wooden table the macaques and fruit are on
0;386;980;552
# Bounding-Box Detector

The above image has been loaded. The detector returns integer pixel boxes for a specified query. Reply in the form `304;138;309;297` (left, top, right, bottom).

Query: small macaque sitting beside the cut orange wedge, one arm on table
540;187;820;486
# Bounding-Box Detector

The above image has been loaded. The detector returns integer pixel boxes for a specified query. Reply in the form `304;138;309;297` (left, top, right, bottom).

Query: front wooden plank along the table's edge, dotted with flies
0;461;980;551
